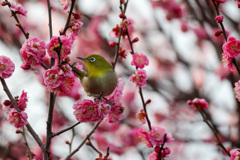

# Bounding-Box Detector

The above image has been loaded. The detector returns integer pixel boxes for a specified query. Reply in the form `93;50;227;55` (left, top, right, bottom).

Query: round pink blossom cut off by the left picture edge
0;56;15;78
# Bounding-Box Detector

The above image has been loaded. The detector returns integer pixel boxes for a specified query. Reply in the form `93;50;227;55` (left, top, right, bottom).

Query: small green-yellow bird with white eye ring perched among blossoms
72;54;117;96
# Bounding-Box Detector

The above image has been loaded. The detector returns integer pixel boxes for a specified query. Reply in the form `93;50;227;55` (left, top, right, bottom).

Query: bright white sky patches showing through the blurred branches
0;0;240;160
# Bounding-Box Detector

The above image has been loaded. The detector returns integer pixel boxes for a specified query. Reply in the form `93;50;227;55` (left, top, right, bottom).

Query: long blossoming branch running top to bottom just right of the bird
109;0;173;159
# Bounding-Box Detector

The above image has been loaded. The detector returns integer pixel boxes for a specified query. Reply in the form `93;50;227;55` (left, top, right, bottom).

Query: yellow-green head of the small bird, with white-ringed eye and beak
77;54;112;72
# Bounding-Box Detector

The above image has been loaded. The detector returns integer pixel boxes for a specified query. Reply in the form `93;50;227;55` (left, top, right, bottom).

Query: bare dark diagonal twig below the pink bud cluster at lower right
195;104;230;157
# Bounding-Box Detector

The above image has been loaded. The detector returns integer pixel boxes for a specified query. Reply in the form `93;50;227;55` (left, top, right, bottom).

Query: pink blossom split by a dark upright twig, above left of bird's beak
47;35;72;60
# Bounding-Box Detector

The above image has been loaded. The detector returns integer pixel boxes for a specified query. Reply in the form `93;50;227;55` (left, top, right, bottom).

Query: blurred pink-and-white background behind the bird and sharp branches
0;0;240;160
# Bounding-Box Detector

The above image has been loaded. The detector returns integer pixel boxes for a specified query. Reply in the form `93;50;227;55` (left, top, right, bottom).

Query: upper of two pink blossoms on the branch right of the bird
131;53;149;69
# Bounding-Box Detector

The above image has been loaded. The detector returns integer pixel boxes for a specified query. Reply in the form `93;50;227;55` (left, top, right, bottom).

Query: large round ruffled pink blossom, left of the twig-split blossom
20;37;46;65
